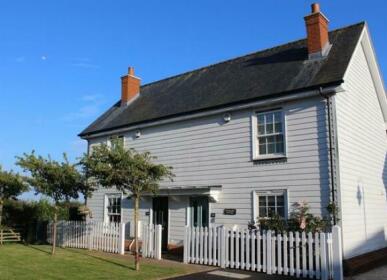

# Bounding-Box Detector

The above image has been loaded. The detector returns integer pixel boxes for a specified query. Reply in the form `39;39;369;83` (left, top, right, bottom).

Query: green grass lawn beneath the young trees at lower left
0;244;197;280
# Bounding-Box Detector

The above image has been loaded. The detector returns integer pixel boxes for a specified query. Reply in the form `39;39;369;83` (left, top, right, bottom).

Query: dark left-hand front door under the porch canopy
153;196;168;250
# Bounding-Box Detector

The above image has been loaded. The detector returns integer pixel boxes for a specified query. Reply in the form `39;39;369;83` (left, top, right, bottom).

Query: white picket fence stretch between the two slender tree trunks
47;221;125;254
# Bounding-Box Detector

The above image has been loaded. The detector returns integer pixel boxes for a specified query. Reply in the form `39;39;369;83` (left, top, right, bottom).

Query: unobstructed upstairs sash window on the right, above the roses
253;111;286;159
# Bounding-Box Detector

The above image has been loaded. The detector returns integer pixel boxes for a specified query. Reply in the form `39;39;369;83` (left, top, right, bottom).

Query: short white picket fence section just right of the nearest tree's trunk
141;224;162;260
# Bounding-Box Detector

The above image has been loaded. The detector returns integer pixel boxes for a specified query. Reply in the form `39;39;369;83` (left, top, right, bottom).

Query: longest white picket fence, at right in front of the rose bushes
184;226;343;280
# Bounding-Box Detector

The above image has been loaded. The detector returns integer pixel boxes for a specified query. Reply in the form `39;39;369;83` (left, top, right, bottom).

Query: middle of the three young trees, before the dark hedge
16;151;87;255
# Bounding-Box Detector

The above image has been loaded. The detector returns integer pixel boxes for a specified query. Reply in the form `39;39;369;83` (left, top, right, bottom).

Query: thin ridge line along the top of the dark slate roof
141;20;366;88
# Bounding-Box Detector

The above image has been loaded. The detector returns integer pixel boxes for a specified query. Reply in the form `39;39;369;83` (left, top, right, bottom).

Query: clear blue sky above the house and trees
0;0;387;200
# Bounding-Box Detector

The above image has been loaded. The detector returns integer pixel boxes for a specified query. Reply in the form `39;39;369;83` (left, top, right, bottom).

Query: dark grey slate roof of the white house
79;22;365;137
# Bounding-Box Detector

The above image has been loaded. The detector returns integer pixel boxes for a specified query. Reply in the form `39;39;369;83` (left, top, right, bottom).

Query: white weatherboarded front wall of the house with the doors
89;95;329;243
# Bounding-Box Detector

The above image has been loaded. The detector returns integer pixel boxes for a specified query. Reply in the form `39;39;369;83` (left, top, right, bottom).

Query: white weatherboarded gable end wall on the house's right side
336;30;387;258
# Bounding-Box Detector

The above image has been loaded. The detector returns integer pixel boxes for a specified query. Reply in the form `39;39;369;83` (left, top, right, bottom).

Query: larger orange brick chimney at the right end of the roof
304;3;332;59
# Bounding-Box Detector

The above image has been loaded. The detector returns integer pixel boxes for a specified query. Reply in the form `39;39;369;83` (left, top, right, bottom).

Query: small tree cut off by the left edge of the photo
0;166;28;227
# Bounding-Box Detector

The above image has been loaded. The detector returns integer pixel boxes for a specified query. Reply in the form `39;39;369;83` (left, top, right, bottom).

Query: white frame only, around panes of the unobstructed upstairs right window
251;109;287;160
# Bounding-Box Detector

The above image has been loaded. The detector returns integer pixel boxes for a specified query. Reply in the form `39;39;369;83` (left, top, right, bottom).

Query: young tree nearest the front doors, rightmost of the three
80;139;174;270
